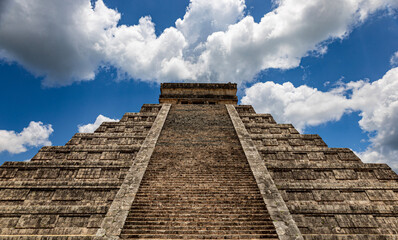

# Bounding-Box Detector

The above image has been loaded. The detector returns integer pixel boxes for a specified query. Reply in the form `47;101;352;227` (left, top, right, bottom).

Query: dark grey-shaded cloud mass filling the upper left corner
0;0;120;86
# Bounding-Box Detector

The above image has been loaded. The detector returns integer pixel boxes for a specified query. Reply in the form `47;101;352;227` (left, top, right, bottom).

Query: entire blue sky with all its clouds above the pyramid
0;0;398;170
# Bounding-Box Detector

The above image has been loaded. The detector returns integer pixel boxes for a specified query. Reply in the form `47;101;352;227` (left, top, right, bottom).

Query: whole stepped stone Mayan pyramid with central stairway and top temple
0;83;398;240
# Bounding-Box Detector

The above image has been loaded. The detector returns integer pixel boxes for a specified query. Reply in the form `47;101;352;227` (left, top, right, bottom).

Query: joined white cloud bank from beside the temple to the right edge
242;67;398;170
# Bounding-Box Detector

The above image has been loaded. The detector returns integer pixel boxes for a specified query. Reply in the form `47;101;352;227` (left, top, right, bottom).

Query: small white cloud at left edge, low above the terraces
0;121;54;154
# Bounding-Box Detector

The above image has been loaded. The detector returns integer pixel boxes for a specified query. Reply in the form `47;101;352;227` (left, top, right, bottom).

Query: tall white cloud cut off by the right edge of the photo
352;67;398;171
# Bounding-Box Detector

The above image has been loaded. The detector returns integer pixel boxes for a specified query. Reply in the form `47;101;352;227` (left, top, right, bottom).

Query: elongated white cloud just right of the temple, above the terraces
242;82;348;130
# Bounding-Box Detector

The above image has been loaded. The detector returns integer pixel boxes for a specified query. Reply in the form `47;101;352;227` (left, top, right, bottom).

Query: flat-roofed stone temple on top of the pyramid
159;83;238;104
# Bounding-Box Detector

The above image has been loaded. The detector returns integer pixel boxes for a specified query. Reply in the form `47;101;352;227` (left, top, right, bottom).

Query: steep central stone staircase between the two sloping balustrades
121;105;278;239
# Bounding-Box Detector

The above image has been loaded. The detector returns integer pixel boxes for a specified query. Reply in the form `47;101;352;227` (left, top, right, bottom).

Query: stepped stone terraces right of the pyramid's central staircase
236;106;398;240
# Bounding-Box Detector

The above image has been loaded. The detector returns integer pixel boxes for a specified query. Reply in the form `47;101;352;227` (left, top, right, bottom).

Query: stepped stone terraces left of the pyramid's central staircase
0;105;161;239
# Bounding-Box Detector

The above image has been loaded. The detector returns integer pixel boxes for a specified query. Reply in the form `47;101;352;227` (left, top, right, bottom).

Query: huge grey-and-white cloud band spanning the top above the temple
0;0;398;85
